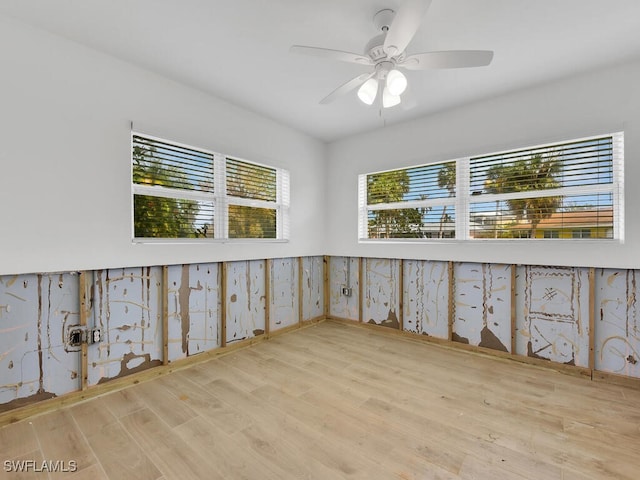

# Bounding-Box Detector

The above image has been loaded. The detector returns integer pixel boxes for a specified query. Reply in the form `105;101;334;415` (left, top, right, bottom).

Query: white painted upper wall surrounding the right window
325;58;640;268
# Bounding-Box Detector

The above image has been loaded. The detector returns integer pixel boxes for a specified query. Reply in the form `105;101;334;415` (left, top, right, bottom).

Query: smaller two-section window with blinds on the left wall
132;134;289;240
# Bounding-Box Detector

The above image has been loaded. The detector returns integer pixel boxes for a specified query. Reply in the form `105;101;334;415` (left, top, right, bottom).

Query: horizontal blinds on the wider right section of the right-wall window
469;136;618;239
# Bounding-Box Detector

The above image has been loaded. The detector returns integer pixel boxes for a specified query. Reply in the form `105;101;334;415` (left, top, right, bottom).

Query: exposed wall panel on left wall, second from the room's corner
269;258;299;331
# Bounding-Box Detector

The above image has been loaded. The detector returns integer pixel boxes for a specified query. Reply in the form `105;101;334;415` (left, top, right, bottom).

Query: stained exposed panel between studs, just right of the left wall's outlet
88;267;162;385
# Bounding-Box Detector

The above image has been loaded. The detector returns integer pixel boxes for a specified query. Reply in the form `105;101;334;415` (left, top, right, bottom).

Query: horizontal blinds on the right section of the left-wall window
226;157;280;238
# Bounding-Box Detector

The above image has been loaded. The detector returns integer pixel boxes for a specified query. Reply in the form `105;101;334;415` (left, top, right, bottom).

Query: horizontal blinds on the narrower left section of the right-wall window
360;161;457;238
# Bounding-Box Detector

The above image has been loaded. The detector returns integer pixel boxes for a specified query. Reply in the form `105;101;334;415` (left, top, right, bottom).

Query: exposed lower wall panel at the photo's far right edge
595;268;640;378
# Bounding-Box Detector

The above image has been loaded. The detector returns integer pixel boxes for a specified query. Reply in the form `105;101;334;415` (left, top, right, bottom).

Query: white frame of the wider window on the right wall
358;132;624;243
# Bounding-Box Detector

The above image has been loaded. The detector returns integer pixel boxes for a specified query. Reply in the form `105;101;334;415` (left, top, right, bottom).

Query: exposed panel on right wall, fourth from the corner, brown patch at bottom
453;263;511;352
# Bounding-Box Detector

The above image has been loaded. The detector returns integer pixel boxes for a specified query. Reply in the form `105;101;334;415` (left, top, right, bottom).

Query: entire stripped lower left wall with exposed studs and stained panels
0;256;324;412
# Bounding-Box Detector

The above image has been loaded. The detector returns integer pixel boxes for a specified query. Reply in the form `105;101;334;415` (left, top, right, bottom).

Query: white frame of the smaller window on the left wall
130;131;290;243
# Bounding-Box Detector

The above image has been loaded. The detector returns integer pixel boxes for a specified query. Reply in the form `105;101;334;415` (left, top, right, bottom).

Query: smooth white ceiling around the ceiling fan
0;0;640;142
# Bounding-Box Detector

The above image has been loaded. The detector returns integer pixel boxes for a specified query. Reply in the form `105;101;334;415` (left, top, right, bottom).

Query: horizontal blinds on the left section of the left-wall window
132;135;215;238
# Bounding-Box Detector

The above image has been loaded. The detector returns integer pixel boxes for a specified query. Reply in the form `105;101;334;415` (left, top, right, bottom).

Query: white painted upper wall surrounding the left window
0;17;326;274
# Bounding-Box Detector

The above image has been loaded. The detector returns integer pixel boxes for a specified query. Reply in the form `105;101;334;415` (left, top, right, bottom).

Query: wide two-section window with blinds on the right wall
359;133;624;240
